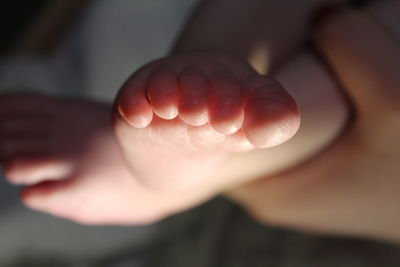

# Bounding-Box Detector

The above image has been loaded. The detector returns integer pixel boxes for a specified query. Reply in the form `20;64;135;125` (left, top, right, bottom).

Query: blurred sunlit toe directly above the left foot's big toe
4;158;74;185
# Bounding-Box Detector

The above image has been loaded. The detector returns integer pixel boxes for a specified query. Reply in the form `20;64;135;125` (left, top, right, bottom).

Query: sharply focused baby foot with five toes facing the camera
115;53;300;190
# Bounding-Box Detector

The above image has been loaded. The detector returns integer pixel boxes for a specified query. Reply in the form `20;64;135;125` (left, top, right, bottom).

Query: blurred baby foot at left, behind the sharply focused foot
0;94;204;224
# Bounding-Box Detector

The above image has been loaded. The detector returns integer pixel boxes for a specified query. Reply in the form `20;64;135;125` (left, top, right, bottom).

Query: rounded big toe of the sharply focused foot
243;77;300;148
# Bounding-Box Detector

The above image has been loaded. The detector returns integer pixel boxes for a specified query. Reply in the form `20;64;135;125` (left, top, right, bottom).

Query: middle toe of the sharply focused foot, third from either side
179;68;208;126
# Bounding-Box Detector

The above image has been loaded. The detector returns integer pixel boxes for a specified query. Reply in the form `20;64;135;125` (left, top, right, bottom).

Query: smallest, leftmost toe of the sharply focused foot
115;73;153;128
